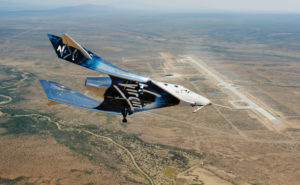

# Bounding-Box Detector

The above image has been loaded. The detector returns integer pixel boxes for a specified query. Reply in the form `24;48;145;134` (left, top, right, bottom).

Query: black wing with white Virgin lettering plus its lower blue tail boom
40;77;179;114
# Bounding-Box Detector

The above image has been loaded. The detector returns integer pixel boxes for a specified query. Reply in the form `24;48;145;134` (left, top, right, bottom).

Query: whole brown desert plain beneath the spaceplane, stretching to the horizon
0;9;300;185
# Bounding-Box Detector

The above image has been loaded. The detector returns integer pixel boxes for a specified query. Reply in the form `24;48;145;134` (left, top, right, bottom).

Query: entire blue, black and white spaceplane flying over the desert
40;34;211;122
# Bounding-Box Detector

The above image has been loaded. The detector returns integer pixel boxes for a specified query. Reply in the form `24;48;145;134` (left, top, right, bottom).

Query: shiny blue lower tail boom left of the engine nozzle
40;80;100;109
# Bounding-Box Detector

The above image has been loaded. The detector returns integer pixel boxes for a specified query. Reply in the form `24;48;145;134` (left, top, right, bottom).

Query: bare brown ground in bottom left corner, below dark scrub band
0;135;124;184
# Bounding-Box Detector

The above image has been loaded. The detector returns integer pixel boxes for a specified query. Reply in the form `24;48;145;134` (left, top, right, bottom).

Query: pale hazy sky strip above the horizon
0;0;300;13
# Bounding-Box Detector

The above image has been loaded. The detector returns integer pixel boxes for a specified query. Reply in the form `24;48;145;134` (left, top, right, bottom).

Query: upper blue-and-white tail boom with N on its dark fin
48;34;150;83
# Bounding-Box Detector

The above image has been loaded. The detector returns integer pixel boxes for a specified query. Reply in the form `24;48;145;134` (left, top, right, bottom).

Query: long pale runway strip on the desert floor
185;57;282;125
